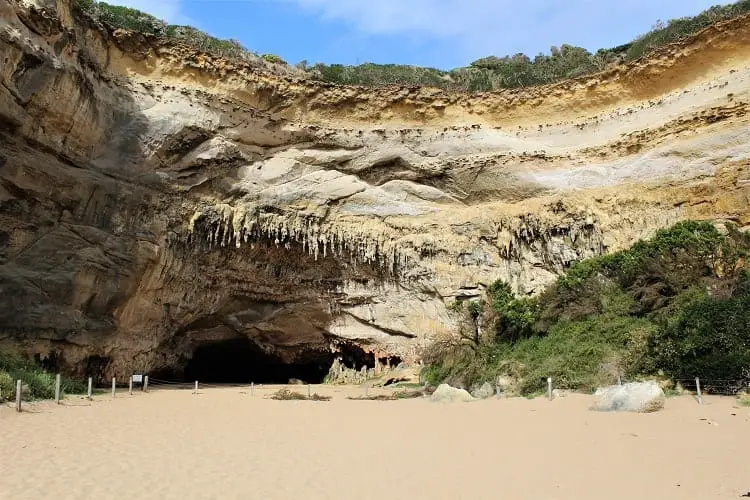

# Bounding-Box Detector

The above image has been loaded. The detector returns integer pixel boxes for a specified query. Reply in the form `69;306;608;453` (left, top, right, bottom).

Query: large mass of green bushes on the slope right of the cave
426;221;750;393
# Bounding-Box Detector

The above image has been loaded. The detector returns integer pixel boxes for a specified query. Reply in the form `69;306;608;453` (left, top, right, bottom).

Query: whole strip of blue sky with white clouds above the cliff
108;0;726;69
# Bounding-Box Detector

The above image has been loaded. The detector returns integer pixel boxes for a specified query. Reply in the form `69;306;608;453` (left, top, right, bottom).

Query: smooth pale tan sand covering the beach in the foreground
0;387;750;500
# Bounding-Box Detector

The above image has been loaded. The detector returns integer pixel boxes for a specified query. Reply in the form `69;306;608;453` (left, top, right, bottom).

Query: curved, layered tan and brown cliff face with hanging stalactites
0;0;750;376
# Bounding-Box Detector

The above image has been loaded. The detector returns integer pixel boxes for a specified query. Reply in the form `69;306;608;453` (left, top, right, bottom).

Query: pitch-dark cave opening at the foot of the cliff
184;338;333;384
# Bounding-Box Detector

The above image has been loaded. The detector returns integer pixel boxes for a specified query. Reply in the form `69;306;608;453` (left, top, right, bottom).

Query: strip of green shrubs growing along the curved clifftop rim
74;0;750;92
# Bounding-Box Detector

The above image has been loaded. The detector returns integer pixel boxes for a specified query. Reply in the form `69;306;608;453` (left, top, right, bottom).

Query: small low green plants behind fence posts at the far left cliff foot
0;353;86;400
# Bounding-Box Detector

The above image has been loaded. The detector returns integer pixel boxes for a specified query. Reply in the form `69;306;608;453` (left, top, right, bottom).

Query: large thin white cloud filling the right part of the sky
288;0;714;56
